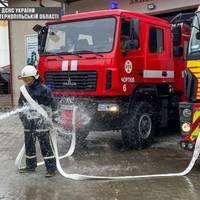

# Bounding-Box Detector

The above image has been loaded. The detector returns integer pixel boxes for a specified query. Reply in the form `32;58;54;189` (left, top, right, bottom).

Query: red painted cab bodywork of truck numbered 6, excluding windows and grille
38;10;184;96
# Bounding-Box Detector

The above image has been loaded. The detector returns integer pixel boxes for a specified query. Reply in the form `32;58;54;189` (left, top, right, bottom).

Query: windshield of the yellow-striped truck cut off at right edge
188;12;200;54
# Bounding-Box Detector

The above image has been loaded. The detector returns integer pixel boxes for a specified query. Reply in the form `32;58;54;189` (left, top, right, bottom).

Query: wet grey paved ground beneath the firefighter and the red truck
0;113;200;200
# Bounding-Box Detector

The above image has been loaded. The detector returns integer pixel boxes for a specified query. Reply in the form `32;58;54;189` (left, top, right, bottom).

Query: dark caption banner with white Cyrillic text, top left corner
0;7;62;20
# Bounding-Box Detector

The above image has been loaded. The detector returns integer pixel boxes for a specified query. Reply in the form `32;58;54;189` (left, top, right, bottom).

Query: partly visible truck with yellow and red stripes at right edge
179;9;200;150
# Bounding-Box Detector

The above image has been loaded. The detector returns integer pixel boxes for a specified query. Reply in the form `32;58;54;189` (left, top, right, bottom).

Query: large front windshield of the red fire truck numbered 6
42;17;116;55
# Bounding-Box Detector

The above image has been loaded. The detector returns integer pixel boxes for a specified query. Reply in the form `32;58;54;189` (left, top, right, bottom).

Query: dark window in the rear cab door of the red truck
149;27;164;53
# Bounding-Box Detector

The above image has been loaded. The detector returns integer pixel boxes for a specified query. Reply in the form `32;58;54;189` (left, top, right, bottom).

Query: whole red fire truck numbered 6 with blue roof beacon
34;9;190;149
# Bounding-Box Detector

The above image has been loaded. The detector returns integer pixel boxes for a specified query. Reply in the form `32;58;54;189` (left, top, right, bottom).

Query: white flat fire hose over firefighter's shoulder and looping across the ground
15;86;200;180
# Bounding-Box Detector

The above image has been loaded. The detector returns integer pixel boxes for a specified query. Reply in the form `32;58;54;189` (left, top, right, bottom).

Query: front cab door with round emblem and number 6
119;17;144;95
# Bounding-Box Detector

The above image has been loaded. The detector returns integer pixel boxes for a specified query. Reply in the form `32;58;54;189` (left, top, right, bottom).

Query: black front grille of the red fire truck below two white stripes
45;71;97;91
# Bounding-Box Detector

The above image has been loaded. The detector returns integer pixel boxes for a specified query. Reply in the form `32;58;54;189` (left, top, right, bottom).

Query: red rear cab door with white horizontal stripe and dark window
143;24;174;83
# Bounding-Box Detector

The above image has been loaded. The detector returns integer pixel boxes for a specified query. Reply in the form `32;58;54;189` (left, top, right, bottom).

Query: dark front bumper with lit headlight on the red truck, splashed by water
57;97;129;131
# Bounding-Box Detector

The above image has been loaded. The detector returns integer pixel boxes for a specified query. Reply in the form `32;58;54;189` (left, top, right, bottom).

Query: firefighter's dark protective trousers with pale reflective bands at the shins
24;129;56;171
